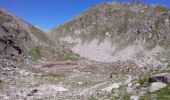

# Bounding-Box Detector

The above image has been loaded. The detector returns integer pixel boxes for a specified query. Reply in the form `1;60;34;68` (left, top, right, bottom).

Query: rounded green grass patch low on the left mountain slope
28;47;42;61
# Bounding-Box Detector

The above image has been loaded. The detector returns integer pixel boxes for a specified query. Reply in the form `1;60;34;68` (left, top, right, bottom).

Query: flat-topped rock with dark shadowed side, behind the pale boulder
149;73;170;83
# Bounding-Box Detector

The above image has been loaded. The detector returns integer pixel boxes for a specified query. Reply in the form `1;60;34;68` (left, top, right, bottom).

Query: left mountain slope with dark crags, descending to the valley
0;9;75;65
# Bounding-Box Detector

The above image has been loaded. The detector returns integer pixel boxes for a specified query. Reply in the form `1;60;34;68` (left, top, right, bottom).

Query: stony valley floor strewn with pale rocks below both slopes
0;59;170;100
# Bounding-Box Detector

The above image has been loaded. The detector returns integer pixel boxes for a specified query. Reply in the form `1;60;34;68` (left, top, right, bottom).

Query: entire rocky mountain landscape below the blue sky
0;2;170;100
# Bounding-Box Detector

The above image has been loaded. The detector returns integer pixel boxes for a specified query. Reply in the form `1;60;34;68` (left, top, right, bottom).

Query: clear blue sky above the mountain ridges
0;0;170;30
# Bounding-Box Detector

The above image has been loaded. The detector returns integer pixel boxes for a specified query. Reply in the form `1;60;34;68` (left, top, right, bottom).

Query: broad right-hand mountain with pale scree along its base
50;2;170;66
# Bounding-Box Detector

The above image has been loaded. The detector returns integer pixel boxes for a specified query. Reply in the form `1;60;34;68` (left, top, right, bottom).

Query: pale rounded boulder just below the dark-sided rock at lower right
149;82;167;92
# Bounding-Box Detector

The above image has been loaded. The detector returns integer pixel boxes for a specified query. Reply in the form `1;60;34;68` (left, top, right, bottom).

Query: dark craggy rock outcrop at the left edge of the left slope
0;9;31;58
